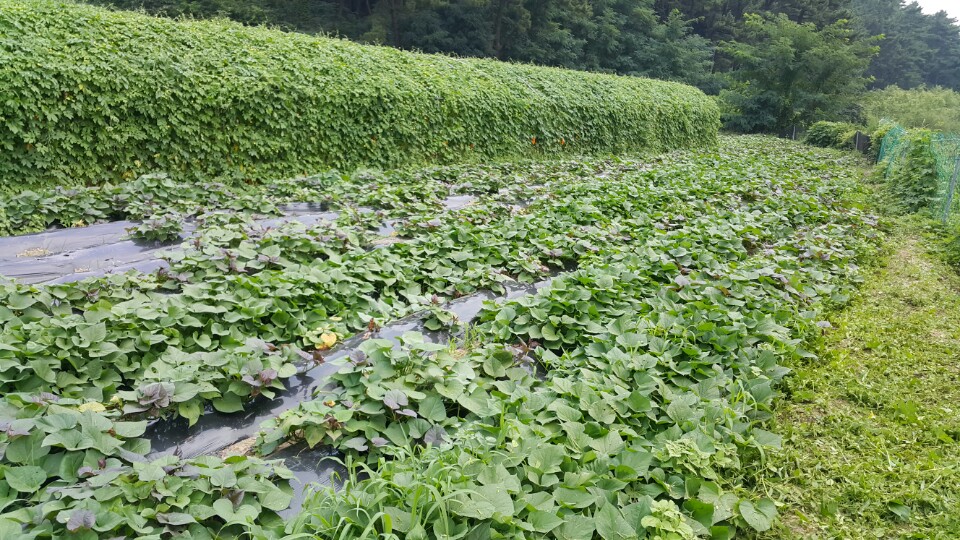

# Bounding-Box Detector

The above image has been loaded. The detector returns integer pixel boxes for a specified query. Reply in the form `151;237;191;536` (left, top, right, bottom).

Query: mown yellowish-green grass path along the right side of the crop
757;221;960;539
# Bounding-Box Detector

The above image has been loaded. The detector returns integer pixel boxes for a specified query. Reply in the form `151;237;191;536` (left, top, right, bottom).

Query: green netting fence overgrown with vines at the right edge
877;121;960;223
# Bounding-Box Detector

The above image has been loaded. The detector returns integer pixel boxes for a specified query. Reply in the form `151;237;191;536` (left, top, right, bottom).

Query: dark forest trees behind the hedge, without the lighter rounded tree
80;0;960;97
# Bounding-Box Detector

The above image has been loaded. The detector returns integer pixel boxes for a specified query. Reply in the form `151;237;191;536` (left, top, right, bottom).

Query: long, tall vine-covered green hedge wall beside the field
0;0;719;191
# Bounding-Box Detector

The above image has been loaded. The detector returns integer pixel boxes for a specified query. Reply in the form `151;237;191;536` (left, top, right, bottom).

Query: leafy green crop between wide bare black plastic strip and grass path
0;138;871;538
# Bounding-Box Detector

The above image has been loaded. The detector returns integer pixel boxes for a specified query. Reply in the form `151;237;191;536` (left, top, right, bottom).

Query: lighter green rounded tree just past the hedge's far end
722;15;877;132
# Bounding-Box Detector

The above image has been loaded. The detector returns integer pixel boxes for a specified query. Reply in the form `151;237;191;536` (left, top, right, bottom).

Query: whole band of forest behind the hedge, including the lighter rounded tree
82;0;960;133
